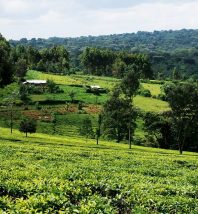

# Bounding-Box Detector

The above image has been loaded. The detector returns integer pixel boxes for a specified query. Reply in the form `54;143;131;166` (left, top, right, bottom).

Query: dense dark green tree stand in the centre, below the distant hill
81;48;153;78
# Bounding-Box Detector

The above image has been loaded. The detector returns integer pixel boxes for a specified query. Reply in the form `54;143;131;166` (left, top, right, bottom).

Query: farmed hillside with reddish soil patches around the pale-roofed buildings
0;71;169;139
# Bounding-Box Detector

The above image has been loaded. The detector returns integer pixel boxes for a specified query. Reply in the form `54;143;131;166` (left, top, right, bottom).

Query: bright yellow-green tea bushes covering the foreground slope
0;128;198;214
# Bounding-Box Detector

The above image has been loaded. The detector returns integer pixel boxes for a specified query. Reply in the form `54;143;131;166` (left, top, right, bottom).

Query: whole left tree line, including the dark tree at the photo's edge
0;34;70;87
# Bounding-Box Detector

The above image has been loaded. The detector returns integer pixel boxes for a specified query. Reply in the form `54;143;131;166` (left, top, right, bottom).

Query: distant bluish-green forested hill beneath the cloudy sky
10;29;198;78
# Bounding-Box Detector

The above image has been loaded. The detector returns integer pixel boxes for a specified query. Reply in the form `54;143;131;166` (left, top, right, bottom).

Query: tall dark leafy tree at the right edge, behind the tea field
164;82;198;154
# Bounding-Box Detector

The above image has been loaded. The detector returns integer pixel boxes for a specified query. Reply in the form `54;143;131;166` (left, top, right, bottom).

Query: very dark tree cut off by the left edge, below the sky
0;34;13;87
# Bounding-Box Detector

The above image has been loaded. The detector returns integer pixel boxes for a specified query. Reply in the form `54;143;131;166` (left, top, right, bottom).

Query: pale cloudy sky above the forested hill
0;0;198;39
